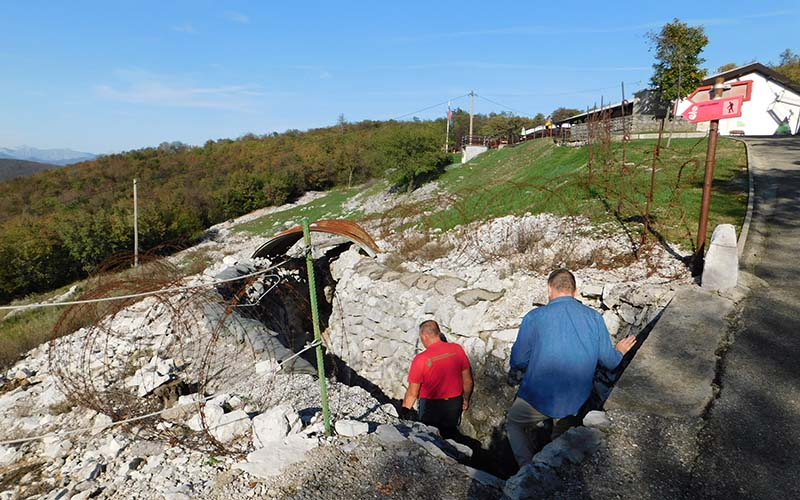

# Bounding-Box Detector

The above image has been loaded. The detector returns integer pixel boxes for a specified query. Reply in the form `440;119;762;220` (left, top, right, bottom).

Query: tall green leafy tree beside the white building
647;19;708;101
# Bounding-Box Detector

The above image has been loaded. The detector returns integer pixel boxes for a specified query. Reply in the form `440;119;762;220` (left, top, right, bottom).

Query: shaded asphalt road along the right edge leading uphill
689;137;800;499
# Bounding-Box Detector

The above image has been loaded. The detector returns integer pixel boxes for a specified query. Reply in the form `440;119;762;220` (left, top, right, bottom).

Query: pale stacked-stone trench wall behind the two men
325;249;674;445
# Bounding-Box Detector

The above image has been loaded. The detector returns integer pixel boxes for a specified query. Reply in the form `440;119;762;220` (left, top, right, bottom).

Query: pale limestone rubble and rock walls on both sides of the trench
0;204;684;500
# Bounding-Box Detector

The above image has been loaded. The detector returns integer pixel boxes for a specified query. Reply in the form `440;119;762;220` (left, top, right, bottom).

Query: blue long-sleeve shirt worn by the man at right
511;296;622;418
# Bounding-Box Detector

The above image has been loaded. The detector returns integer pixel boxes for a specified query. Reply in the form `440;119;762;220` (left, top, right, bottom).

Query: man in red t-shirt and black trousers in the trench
403;320;473;439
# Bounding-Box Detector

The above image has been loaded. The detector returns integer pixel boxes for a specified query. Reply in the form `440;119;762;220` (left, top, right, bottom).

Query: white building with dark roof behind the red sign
677;63;800;135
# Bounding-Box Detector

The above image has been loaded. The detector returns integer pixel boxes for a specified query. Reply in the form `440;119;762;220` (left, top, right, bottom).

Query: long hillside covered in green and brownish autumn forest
0;110;532;303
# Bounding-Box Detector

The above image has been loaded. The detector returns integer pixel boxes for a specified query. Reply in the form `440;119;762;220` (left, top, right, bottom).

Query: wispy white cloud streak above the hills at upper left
93;69;265;111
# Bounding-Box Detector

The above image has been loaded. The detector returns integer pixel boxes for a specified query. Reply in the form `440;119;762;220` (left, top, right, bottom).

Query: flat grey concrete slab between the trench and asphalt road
606;287;734;417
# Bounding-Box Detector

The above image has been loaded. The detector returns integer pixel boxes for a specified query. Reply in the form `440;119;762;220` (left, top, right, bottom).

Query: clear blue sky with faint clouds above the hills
0;0;800;153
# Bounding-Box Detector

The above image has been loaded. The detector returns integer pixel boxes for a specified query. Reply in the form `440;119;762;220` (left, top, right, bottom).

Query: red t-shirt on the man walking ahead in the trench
408;342;469;399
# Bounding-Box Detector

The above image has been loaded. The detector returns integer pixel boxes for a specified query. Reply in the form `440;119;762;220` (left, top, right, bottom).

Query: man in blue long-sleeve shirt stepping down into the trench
506;269;636;466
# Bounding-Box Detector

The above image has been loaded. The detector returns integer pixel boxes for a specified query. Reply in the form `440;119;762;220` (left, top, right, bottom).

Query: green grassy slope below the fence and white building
240;138;747;252
